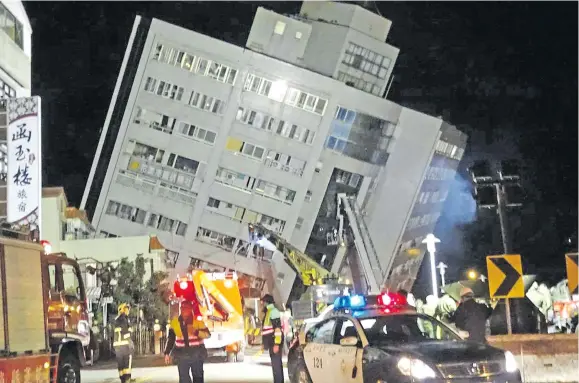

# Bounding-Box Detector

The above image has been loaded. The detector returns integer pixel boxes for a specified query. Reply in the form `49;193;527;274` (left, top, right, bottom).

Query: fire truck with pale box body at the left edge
0;237;91;383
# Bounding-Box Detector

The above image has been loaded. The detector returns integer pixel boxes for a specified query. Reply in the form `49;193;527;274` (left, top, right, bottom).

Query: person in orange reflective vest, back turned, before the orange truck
165;301;211;383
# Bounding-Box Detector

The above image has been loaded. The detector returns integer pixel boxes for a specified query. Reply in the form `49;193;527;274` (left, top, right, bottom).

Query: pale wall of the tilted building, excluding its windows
81;9;466;296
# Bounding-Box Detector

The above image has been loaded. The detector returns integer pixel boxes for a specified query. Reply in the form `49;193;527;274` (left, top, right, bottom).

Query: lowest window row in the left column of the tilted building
105;201;187;236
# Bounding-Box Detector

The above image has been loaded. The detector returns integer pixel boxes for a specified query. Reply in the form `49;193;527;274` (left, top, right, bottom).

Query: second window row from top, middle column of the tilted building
235;107;316;145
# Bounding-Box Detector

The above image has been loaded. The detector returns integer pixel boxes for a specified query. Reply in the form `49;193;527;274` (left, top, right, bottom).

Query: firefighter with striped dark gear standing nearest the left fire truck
113;303;134;383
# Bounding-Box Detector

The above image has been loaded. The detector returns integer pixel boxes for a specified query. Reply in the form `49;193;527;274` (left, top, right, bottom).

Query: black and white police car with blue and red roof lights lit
288;293;522;383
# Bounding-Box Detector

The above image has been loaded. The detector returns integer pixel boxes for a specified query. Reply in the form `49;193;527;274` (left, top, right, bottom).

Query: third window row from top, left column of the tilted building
133;107;217;145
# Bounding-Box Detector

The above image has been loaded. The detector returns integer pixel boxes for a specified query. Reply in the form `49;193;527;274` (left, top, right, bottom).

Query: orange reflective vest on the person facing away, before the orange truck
165;316;211;354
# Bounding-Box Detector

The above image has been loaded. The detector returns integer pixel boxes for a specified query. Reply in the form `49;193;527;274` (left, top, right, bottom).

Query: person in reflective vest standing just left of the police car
261;294;284;383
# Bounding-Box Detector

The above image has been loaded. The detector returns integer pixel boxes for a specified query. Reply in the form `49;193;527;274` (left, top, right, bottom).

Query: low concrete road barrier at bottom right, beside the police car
487;334;579;383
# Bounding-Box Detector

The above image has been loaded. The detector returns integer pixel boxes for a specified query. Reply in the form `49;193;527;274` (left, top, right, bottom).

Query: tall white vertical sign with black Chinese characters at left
6;97;42;231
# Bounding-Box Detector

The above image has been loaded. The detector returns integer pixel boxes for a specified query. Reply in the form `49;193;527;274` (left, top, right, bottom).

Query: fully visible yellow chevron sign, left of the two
487;254;525;298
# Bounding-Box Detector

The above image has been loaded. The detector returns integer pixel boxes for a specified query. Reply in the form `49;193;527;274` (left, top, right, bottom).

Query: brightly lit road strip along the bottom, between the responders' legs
81;362;289;383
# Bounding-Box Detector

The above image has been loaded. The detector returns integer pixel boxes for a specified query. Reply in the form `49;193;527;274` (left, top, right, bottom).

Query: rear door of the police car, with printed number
303;318;340;382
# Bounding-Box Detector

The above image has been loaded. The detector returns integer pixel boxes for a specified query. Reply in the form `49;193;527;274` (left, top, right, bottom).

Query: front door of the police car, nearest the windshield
334;317;363;383
